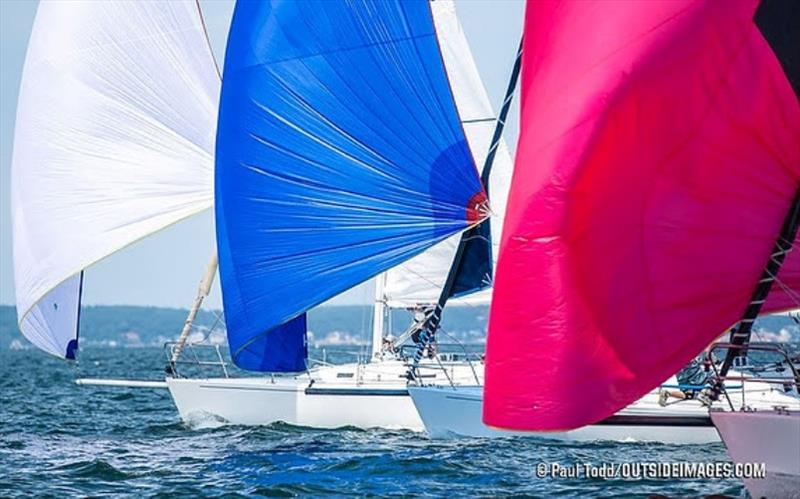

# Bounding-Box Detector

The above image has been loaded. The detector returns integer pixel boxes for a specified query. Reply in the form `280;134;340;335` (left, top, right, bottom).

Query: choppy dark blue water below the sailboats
0;348;745;497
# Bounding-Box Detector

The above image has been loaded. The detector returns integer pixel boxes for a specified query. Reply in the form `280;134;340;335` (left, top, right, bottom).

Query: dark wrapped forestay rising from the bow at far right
713;189;800;382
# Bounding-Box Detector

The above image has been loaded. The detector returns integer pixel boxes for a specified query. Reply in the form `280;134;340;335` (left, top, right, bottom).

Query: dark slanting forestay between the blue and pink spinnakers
409;40;523;378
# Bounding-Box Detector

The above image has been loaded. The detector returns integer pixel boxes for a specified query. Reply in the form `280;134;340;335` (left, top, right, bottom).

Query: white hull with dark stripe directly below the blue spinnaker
166;360;482;431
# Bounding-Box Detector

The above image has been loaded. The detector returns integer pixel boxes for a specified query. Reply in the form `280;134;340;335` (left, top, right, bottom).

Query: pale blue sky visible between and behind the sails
0;0;524;308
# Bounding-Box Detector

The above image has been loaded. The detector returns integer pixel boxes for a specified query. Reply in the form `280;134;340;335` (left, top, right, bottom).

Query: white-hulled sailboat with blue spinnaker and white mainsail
171;1;511;430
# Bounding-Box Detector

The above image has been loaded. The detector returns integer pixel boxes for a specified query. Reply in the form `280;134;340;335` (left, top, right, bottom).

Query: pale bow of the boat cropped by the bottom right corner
711;410;800;499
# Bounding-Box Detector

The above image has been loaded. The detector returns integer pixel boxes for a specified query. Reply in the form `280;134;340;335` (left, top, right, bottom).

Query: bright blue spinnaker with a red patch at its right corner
216;0;487;371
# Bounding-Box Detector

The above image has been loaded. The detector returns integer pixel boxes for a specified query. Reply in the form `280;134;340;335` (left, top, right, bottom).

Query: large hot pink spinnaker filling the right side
484;0;800;431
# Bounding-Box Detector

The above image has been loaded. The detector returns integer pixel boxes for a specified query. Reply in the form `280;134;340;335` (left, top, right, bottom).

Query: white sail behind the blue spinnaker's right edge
384;0;513;307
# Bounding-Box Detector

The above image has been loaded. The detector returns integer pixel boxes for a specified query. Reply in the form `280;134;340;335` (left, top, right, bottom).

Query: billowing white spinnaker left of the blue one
11;0;220;357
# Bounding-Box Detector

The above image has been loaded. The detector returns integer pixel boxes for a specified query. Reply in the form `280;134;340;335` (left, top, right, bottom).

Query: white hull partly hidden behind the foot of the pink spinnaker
409;383;800;444
